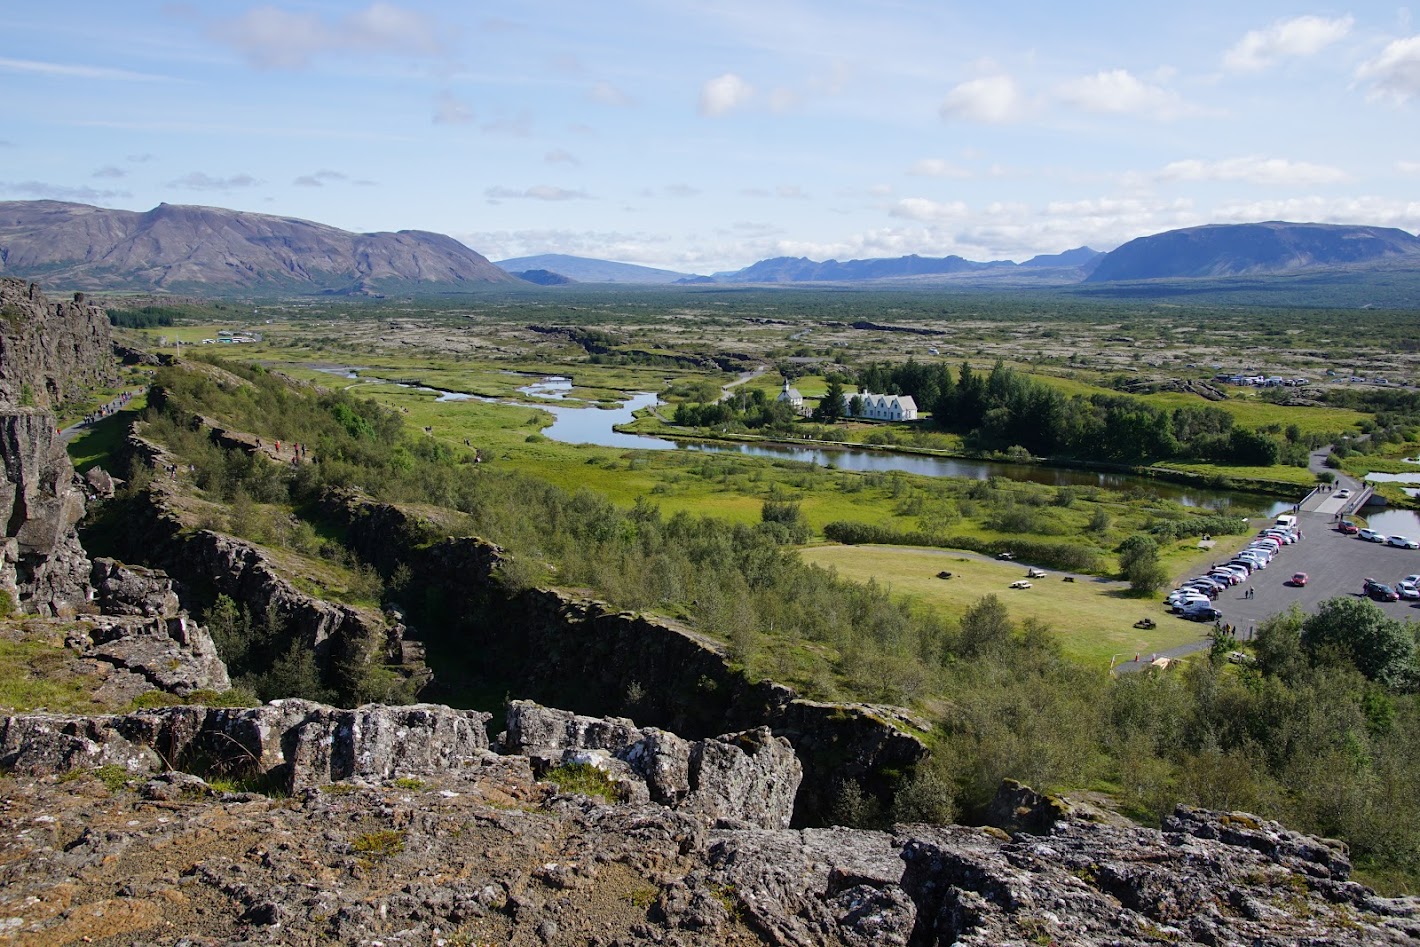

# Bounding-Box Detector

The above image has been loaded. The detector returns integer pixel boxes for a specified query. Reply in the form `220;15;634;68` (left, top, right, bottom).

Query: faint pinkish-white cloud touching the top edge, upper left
207;3;443;70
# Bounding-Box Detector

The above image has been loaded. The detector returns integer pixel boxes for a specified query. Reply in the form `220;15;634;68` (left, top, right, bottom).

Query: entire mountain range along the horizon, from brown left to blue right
0;200;1420;298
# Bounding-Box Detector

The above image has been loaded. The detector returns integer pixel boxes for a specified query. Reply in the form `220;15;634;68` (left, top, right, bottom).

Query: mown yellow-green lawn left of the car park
801;545;1211;667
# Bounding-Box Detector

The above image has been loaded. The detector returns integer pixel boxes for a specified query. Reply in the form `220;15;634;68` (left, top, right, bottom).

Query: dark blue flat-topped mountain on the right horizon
1088;220;1420;283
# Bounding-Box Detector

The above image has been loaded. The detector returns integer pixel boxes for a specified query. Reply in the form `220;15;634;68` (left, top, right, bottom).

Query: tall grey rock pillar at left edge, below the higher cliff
0;407;89;615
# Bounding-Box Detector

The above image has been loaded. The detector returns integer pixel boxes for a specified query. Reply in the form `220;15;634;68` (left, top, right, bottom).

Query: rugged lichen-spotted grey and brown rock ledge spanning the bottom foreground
0;701;1420;947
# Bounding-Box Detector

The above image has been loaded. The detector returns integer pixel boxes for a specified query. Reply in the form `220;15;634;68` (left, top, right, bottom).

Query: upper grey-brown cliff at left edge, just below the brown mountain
0;278;115;407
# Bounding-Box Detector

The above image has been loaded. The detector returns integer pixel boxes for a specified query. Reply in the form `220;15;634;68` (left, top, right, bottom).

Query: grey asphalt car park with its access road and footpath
1118;451;1420;672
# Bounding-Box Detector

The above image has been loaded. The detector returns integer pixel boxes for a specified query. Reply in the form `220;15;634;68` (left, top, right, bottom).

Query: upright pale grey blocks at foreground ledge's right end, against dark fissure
500;700;804;828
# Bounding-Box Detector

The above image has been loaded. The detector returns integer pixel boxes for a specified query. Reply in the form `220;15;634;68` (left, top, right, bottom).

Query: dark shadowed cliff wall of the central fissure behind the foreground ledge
327;494;927;823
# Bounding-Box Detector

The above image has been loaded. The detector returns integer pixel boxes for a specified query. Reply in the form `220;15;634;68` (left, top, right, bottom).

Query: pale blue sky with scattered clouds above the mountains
0;0;1420;273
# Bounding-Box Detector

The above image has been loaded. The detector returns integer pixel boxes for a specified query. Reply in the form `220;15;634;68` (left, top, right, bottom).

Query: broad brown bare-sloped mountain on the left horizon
0;200;518;292
